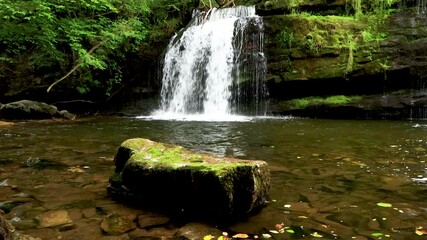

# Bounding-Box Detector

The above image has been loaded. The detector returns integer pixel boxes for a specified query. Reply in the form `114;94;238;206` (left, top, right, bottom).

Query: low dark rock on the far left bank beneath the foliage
0;100;76;120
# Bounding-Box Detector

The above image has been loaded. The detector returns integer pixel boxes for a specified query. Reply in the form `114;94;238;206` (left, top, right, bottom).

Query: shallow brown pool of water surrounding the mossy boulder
0;117;427;239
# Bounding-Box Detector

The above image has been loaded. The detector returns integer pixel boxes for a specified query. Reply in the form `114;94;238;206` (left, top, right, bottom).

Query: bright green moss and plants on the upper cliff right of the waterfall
277;5;394;77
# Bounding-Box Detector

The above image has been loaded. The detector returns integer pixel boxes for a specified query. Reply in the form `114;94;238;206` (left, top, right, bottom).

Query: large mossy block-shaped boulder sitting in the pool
108;138;270;221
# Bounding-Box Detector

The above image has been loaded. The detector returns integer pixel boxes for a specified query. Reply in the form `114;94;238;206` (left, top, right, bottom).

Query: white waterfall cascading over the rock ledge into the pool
154;6;268;120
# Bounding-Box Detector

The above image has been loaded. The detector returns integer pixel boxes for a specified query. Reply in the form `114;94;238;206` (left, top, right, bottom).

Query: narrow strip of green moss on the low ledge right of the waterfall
284;95;362;109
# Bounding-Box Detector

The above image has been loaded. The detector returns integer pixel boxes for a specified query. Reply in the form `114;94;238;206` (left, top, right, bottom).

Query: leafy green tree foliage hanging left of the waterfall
0;0;193;96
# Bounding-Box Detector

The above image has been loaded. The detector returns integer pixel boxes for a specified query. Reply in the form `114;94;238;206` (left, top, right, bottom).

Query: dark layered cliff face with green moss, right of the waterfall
257;0;427;118
